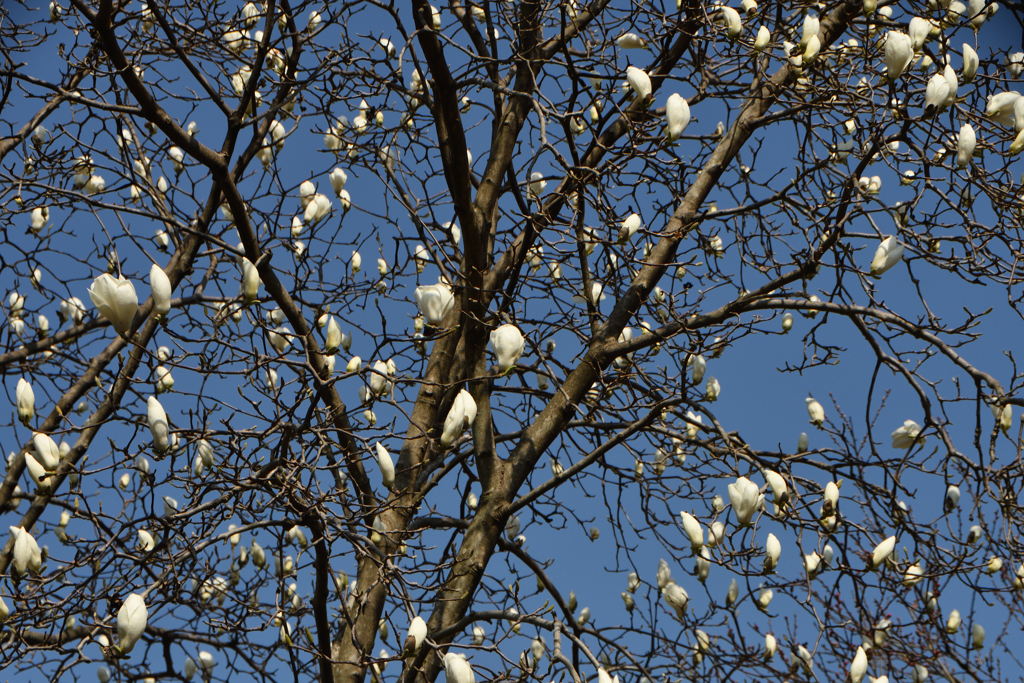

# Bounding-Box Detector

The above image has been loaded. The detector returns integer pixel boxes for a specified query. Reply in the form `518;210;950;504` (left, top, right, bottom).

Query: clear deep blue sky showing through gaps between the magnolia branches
0;0;1022;680
